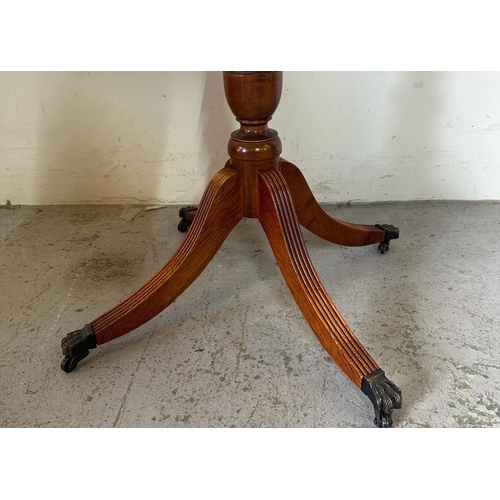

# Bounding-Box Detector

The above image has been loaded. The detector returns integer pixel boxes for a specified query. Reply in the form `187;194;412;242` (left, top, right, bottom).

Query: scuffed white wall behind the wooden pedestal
0;72;500;204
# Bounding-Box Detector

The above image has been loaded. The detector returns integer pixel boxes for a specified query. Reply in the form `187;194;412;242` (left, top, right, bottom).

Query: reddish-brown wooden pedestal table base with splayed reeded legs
61;71;401;426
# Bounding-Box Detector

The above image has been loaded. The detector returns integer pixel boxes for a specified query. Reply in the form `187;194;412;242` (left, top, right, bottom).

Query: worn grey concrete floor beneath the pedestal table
0;202;500;427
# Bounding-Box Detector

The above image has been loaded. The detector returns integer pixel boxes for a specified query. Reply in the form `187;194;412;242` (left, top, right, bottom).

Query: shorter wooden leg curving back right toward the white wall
280;159;399;248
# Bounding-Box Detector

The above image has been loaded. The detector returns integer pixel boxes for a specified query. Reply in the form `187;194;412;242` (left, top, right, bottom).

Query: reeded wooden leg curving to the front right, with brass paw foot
259;170;401;427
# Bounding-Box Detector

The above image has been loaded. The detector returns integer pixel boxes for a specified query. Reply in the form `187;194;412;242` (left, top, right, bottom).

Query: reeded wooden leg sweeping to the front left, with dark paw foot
61;167;242;366
